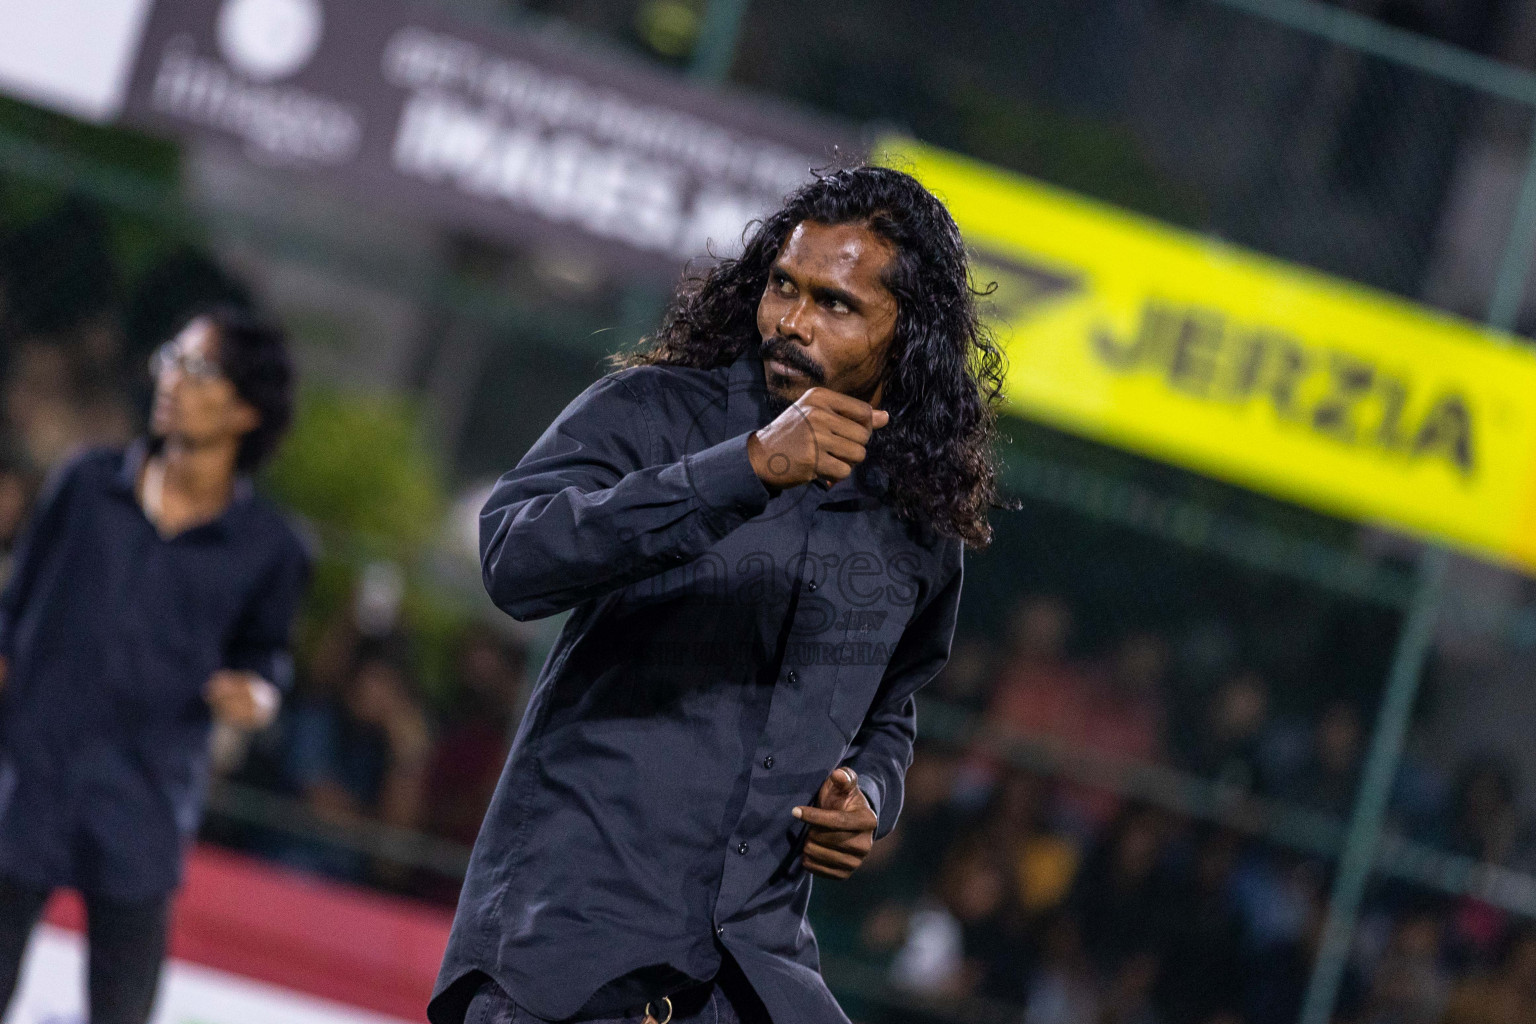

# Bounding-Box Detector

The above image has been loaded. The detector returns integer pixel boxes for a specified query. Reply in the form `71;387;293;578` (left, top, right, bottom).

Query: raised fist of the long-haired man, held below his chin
746;387;891;490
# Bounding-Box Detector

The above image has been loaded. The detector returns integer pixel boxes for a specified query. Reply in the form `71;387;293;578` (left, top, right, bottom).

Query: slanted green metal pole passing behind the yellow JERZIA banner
1301;112;1536;1024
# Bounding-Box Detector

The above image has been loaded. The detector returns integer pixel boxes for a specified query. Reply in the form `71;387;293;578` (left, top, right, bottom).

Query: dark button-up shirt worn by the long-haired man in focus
430;348;962;1024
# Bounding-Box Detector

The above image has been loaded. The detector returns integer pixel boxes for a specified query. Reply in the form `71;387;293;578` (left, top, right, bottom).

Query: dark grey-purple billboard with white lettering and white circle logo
124;0;859;278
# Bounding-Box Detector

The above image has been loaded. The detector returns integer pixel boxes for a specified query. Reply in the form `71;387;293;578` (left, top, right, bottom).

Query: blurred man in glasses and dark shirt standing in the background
0;310;309;1024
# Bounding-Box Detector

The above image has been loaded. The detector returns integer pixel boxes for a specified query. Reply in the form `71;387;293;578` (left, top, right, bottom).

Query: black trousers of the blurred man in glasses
0;878;170;1024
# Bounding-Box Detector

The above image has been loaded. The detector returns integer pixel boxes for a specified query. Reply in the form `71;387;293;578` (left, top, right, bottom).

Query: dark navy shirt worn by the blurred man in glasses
0;442;309;900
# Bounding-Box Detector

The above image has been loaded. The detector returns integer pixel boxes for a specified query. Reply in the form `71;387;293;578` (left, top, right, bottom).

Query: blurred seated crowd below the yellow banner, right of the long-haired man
813;596;1536;1024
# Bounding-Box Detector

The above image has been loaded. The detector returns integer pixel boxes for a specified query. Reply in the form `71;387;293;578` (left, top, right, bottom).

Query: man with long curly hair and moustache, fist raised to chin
430;167;1001;1024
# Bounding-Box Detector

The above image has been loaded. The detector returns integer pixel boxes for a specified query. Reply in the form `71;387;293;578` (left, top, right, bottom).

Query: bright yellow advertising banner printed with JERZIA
882;140;1536;570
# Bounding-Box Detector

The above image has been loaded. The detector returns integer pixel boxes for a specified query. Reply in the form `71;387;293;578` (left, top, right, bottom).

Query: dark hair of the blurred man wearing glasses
186;306;293;473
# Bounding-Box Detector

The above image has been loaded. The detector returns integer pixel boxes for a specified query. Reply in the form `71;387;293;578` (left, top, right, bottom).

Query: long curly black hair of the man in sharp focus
613;166;1005;548
